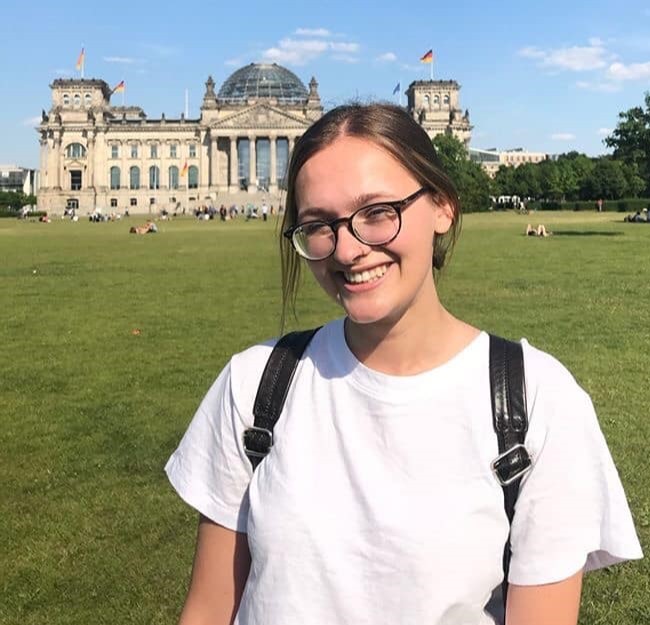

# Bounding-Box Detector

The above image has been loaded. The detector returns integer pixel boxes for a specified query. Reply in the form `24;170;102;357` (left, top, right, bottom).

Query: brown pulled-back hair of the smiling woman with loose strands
280;103;461;327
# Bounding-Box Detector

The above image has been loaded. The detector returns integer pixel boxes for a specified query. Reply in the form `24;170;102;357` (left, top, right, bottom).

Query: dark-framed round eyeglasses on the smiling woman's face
284;187;429;260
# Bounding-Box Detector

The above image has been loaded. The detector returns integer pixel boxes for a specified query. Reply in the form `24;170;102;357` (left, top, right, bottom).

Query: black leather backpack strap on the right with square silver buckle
490;335;532;609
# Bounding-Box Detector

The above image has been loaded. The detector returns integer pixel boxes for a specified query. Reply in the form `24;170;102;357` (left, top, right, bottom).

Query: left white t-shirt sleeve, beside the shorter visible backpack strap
165;363;252;532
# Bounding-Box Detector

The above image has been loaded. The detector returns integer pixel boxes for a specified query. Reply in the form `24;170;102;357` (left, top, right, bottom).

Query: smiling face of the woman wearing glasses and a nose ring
296;136;453;324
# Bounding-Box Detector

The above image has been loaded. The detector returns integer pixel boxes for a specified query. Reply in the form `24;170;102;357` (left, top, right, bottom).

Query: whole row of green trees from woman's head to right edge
433;93;650;212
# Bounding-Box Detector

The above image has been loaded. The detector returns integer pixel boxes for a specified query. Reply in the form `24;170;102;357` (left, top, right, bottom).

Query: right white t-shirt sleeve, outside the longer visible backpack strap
509;348;643;585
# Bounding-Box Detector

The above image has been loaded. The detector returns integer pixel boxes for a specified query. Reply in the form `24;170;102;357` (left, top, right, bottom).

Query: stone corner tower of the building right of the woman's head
406;80;472;147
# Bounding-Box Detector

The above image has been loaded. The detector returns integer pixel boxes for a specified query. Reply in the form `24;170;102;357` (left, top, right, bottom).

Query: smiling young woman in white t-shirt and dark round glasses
166;104;641;625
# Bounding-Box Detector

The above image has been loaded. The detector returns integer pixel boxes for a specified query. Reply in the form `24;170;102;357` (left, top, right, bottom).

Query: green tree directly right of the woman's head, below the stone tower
433;135;491;213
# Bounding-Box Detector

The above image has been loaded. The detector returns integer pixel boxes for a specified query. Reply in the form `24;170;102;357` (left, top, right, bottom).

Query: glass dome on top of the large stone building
217;63;308;104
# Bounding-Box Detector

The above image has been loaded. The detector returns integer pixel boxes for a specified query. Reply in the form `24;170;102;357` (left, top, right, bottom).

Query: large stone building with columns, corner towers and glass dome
38;63;471;213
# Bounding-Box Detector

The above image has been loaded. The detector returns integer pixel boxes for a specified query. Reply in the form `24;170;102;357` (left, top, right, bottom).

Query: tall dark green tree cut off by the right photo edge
604;92;650;191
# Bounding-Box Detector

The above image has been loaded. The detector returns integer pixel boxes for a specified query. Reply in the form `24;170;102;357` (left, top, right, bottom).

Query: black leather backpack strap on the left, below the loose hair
244;328;320;470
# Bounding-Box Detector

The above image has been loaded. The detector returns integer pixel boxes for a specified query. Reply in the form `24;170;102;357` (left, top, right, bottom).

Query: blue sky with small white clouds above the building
0;0;650;167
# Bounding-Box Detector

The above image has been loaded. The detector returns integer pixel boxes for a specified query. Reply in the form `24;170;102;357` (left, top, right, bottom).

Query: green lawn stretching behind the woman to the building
0;213;650;625
